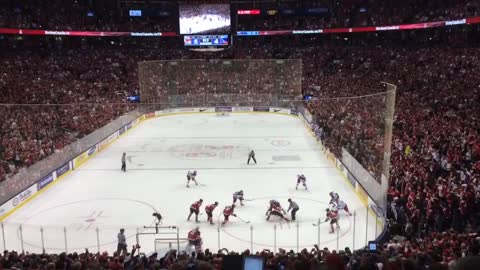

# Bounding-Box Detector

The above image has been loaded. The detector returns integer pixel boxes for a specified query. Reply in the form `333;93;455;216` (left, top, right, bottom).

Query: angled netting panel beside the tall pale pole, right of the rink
306;86;395;213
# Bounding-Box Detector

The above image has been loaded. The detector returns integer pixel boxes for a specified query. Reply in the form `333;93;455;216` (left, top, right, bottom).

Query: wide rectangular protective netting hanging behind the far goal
139;59;302;107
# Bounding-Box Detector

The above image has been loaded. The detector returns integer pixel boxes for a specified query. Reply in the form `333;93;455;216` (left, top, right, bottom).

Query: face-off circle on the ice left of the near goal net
16;198;156;251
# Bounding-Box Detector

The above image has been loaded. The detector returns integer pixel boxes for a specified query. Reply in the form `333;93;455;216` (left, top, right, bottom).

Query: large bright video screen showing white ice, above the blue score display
179;4;230;35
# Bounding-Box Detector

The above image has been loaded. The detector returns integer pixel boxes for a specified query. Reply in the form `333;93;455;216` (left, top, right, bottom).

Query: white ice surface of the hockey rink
4;113;380;253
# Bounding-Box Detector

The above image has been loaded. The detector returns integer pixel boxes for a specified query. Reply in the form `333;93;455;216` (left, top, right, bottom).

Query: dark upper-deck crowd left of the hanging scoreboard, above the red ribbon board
0;0;178;32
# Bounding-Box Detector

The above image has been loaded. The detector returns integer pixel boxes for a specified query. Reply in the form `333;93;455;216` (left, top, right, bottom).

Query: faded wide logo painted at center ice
168;144;249;159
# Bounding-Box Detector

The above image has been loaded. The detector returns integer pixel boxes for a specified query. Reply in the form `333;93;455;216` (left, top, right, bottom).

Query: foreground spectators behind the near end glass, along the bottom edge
0;232;480;270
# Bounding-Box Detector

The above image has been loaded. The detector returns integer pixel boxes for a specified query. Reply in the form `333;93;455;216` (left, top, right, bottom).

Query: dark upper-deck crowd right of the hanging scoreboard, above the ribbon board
237;0;480;30
